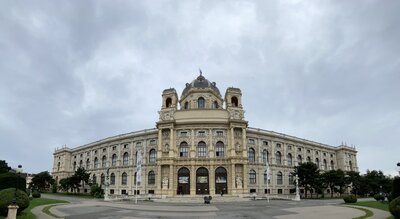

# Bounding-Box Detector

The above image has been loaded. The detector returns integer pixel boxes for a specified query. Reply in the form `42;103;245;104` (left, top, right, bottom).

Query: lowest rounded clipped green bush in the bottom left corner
0;188;29;216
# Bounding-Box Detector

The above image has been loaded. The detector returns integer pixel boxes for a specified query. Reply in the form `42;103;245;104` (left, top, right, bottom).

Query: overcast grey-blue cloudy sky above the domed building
0;0;400;175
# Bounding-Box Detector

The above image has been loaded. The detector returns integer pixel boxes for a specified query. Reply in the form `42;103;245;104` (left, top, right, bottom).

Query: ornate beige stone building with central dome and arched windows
52;73;358;197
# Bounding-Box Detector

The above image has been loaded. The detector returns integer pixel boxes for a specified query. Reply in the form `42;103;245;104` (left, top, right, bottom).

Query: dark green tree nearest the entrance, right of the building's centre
294;162;320;197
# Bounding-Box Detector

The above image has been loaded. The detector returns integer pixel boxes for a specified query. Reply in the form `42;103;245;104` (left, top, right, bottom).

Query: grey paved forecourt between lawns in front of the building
32;195;390;219
